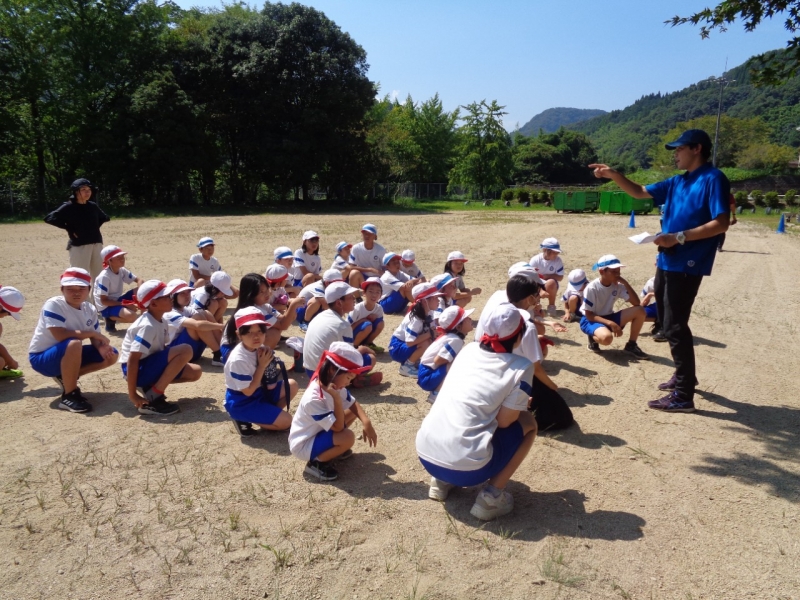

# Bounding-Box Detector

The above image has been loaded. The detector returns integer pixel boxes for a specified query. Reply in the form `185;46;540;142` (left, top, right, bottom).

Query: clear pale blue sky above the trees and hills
172;0;789;130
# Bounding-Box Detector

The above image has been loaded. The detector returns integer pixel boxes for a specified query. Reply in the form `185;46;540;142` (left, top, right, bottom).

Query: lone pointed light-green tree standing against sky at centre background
449;100;513;198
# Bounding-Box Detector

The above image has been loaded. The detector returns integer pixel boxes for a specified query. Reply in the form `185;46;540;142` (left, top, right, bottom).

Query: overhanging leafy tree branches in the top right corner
665;0;800;85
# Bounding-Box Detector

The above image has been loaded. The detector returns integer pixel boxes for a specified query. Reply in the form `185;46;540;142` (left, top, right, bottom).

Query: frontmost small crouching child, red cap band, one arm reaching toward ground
289;342;378;481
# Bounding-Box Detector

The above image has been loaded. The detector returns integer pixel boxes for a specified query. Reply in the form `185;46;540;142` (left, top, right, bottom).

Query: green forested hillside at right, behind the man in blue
569;51;800;170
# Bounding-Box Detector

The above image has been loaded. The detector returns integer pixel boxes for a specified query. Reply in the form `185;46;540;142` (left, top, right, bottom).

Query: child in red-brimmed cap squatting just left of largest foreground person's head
417;306;475;404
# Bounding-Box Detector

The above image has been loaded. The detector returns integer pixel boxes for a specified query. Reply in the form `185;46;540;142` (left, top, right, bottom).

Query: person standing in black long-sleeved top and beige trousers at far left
44;179;111;280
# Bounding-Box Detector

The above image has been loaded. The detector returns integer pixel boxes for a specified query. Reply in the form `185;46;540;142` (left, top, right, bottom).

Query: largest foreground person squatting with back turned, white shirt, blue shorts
416;303;537;521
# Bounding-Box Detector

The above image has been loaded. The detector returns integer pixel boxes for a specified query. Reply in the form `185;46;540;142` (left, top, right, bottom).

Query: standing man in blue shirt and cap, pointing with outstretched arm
589;129;731;412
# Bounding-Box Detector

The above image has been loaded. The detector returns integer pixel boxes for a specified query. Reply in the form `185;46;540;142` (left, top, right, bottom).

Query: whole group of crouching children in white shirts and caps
0;223;657;519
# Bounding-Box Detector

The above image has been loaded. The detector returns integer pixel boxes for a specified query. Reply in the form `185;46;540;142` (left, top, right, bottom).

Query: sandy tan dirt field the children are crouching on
0;213;800;600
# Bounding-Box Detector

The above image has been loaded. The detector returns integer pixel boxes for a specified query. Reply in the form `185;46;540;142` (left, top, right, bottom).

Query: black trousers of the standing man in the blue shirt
655;269;703;401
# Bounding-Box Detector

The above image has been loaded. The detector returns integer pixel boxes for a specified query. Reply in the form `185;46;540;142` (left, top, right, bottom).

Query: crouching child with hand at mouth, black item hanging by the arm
225;306;297;437
